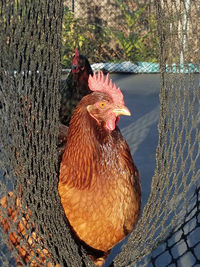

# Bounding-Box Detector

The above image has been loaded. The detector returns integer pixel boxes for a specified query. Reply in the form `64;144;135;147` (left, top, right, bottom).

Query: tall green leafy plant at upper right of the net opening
110;0;158;62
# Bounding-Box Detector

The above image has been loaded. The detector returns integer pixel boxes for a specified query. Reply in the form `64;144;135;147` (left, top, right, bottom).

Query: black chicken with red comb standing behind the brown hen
58;48;93;158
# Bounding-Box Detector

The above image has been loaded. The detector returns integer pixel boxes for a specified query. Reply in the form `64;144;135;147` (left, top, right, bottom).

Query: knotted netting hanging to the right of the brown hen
112;1;200;266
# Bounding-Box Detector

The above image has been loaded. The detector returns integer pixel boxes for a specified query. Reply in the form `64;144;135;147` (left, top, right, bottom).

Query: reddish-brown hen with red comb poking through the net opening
58;72;141;266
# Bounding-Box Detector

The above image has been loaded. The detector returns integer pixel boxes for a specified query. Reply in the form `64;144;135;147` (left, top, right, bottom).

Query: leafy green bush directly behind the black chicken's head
61;8;115;68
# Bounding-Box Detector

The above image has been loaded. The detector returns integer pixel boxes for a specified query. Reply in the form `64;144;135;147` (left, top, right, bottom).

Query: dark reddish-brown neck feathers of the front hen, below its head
60;105;122;189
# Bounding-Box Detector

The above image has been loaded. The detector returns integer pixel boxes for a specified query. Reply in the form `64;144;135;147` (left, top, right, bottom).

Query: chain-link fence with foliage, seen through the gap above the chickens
62;0;159;71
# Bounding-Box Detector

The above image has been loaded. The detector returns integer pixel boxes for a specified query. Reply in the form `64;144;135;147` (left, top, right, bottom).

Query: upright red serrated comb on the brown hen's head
88;71;124;105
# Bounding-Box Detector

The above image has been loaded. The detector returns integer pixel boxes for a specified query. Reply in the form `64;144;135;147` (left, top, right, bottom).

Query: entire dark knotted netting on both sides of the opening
0;0;200;267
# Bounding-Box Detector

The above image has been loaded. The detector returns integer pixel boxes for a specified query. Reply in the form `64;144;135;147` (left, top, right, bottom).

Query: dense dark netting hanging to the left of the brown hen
0;0;90;266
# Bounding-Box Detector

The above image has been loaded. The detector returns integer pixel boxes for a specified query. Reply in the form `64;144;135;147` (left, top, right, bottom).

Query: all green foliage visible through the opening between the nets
61;3;159;68
